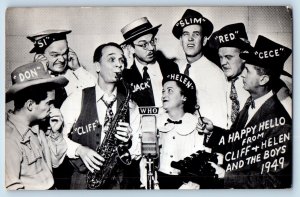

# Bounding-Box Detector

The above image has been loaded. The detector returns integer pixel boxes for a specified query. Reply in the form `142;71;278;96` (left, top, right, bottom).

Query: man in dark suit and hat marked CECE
199;36;292;189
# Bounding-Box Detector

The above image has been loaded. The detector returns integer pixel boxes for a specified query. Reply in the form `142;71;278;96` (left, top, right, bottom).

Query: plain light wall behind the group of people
5;6;292;91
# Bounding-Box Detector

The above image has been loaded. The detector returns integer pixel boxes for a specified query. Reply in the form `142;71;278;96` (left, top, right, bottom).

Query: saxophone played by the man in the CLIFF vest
87;73;131;189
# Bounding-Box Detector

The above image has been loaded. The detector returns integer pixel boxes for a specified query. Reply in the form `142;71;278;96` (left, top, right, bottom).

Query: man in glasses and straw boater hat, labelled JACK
121;17;179;107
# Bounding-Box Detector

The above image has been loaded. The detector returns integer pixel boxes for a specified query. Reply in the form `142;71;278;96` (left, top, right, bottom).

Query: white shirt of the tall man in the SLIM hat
178;56;227;129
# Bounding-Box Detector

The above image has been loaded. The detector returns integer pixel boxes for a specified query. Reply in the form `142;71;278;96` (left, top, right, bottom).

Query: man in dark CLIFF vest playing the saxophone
61;43;140;189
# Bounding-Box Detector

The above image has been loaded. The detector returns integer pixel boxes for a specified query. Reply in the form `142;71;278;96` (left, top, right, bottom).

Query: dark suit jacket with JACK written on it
124;51;179;106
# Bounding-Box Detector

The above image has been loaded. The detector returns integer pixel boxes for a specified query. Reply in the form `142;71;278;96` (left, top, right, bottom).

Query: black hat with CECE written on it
240;35;292;74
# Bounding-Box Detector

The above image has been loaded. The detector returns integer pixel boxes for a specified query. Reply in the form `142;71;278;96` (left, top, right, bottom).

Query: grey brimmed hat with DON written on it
6;62;69;102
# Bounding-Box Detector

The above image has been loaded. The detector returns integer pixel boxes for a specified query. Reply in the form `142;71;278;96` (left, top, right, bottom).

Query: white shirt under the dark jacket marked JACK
135;59;163;107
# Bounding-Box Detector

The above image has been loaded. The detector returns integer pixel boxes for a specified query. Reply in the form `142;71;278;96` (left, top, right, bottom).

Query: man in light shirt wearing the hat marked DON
5;62;68;190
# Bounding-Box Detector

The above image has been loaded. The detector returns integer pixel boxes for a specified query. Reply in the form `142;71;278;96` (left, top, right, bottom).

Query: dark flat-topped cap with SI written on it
27;29;72;53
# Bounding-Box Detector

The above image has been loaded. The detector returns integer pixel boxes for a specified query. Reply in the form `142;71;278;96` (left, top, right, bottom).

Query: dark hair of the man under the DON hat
14;83;58;110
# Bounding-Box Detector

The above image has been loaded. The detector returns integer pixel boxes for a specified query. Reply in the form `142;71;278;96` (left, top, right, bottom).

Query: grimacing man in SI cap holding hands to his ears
27;30;96;102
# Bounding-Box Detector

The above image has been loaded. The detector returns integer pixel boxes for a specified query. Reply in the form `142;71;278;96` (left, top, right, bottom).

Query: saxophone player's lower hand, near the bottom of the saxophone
76;146;104;172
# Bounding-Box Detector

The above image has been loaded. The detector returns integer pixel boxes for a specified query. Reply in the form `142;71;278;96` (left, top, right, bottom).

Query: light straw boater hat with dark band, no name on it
121;17;161;45
